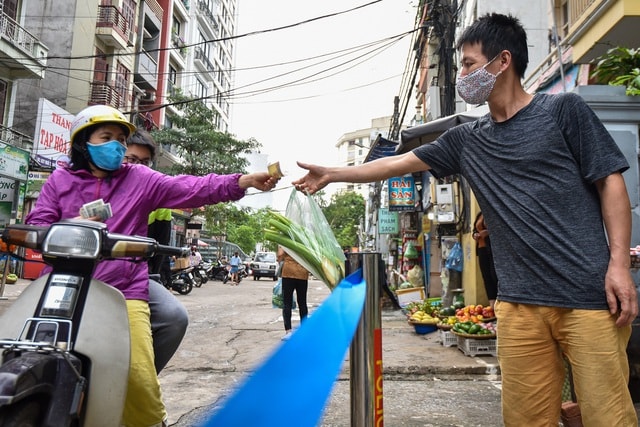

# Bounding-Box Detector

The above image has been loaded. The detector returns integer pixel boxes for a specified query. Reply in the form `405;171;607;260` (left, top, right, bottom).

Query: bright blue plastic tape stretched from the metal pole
203;270;366;427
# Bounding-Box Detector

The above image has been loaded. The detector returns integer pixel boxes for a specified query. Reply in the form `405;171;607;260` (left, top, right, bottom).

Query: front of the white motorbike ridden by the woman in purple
0;220;189;427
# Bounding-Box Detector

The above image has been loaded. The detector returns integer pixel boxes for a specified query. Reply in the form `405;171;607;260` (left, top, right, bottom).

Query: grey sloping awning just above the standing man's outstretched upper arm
396;105;489;154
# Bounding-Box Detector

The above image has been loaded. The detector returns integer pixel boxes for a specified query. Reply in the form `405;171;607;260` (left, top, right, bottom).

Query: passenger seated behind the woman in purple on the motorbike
124;129;189;373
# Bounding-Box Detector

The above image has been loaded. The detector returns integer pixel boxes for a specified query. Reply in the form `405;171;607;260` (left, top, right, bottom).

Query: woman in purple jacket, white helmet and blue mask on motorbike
26;105;278;427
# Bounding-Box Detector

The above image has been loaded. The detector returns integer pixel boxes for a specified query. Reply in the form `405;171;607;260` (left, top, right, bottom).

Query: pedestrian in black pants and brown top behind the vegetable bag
278;246;309;340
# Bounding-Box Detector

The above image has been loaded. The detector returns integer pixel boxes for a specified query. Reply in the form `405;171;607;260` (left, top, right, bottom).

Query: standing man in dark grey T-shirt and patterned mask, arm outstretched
293;13;638;427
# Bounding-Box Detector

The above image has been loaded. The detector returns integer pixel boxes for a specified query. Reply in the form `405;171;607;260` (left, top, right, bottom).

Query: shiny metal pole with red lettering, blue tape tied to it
346;252;384;427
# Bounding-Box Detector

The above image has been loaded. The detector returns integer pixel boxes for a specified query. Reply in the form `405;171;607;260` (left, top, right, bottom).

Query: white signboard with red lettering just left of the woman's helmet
33;98;74;169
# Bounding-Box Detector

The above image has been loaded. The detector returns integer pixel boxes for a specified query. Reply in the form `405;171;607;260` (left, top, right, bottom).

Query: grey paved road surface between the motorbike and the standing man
155;279;501;427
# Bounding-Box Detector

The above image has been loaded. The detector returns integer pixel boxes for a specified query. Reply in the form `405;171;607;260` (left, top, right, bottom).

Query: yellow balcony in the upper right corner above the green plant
562;0;640;64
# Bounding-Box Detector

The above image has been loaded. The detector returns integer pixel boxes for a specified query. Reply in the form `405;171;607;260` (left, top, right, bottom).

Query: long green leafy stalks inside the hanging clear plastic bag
264;211;345;289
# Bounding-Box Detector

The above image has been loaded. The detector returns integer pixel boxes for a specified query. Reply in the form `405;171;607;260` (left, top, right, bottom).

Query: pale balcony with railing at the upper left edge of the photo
0;14;49;80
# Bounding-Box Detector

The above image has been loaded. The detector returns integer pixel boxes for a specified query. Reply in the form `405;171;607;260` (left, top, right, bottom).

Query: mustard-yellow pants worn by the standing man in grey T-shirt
495;301;638;427
